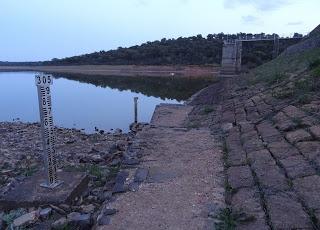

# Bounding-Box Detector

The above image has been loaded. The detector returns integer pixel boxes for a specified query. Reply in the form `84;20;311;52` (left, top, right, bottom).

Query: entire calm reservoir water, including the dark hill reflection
0;72;215;133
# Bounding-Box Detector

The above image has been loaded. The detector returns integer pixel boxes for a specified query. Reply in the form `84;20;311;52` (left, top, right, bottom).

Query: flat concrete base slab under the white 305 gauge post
0;172;89;210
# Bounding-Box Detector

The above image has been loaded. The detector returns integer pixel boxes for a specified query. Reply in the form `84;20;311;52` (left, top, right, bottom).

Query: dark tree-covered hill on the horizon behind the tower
0;33;302;68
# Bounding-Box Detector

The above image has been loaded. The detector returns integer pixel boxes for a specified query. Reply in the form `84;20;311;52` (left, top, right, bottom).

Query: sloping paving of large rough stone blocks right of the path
208;78;320;229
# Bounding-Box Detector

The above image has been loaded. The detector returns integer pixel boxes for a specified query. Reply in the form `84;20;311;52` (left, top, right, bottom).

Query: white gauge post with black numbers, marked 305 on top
35;74;63;188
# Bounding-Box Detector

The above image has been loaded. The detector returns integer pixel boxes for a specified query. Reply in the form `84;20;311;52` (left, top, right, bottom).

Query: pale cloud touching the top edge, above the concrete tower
224;0;292;11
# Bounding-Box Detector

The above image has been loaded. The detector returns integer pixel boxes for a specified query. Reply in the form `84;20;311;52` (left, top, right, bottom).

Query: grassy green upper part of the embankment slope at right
248;23;320;103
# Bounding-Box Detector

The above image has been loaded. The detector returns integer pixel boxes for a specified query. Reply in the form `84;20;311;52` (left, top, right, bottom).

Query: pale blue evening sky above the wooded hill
0;0;320;61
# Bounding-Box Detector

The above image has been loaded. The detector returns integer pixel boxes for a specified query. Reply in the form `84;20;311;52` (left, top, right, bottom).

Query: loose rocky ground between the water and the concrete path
0;122;147;229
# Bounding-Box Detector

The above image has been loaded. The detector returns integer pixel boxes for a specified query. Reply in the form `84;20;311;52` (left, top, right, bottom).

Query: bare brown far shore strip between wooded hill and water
0;65;220;77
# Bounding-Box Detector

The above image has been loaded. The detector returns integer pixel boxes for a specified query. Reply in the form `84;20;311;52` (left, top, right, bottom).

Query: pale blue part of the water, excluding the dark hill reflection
0;72;183;133
